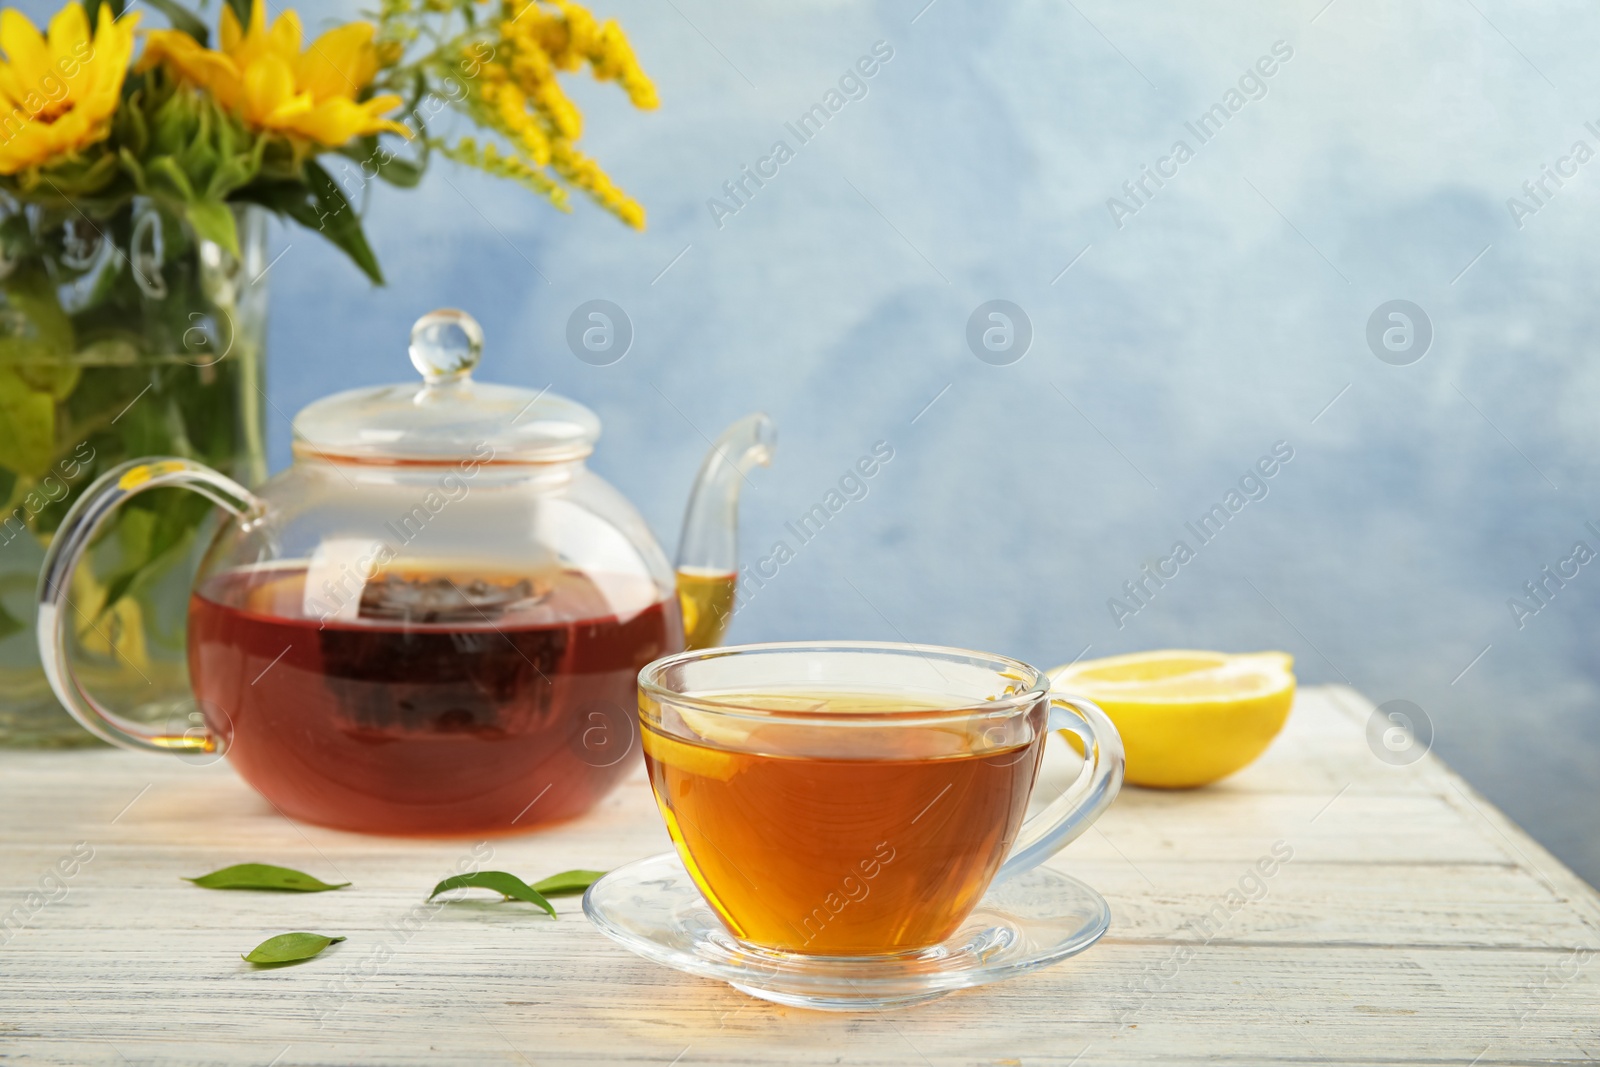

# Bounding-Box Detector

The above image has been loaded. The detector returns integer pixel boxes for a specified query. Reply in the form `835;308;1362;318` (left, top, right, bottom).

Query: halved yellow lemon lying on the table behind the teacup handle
1050;649;1294;789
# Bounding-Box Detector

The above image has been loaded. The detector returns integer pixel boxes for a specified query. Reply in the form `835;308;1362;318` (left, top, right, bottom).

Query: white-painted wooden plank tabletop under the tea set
0;689;1600;1067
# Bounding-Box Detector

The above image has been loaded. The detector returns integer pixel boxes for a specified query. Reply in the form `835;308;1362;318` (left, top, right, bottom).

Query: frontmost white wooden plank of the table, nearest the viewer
6;947;1600;1064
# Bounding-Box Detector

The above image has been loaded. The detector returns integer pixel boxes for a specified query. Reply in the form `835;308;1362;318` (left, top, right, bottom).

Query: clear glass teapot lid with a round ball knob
294;309;600;462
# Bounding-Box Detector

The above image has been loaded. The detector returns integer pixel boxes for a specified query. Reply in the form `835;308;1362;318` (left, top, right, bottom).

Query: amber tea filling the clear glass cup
645;693;1042;955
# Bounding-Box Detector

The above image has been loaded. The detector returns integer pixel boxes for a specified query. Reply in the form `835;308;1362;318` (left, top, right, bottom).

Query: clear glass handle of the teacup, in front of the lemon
995;696;1123;885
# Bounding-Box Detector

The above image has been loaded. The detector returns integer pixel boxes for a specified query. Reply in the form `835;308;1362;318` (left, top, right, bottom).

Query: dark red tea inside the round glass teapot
189;565;683;833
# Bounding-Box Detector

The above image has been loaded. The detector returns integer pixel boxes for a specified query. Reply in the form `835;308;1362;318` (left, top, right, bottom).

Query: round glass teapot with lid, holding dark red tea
38;310;774;835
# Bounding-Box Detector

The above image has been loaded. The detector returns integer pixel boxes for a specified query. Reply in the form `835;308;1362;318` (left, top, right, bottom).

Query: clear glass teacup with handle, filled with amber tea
638;641;1123;957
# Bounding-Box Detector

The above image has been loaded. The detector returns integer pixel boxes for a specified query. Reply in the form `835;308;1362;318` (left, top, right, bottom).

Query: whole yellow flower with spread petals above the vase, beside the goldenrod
139;0;410;147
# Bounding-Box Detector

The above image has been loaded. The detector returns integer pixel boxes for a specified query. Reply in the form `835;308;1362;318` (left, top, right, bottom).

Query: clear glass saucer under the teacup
584;853;1110;1011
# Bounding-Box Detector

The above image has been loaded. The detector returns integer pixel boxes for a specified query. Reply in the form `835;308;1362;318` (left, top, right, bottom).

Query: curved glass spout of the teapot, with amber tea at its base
677;413;778;649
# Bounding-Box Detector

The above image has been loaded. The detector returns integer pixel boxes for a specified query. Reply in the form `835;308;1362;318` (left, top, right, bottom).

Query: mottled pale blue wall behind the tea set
43;0;1600;881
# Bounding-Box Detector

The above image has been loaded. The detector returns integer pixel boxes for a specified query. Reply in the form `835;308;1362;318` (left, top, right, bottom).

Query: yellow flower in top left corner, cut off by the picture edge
0;3;139;174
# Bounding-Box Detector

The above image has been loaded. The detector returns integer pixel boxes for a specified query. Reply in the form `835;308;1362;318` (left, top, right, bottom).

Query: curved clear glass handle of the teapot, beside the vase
37;458;266;753
